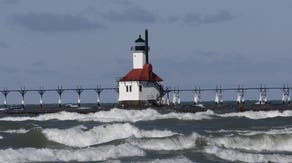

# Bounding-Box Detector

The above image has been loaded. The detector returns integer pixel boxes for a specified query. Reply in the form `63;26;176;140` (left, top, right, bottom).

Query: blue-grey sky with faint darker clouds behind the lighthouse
0;0;292;102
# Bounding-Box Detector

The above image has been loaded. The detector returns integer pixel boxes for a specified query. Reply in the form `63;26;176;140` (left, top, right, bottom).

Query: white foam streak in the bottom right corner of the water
204;146;292;163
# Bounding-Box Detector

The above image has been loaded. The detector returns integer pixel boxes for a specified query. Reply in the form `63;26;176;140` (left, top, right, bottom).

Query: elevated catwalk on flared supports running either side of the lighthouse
0;84;292;109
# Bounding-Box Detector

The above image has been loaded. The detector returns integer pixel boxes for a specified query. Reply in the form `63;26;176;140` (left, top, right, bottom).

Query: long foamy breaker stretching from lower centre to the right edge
122;125;292;152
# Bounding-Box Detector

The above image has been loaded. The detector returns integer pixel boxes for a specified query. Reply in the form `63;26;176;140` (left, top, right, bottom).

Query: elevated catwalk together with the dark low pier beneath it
0;85;292;114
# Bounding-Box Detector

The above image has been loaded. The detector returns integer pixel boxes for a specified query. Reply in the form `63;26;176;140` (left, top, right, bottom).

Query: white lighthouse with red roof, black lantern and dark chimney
118;30;164;107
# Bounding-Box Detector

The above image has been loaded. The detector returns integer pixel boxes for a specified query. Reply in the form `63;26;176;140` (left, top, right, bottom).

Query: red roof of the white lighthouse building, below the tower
120;64;163;81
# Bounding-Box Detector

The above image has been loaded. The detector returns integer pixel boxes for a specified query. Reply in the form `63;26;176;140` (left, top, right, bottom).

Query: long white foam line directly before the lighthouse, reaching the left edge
0;108;214;122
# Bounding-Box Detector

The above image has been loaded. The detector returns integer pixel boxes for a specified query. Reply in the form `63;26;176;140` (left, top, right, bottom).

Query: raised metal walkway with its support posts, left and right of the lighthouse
0;83;292;108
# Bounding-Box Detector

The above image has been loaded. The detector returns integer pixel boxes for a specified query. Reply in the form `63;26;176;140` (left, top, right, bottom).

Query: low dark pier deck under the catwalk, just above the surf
0;102;292;115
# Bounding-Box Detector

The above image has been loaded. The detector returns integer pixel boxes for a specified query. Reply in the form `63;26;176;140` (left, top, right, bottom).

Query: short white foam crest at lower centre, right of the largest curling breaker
129;133;200;150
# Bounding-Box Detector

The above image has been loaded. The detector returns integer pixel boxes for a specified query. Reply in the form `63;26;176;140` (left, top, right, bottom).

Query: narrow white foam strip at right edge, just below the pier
216;110;292;119
